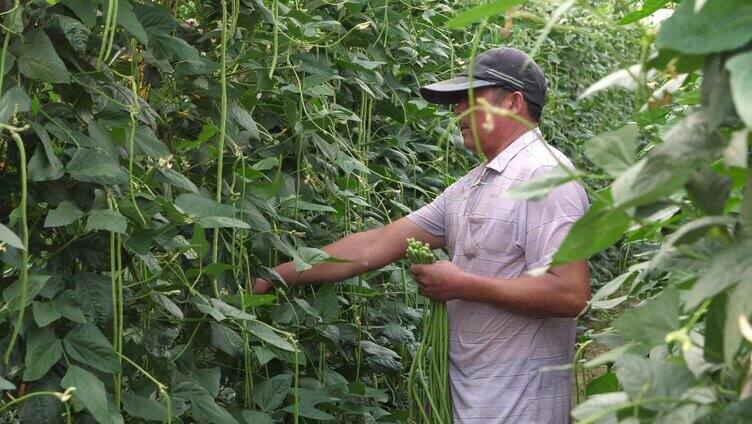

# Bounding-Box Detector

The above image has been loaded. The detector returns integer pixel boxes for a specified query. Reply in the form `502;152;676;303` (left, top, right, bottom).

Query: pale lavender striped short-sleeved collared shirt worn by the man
408;128;588;424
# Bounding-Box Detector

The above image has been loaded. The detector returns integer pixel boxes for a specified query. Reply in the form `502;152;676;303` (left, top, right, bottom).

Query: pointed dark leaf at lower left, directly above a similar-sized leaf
63;324;120;373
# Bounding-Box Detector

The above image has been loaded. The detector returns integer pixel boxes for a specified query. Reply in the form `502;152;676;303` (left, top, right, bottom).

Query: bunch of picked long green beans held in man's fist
407;238;452;423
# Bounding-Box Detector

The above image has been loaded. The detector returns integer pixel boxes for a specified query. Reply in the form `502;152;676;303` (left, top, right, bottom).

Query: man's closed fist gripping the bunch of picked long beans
410;261;465;301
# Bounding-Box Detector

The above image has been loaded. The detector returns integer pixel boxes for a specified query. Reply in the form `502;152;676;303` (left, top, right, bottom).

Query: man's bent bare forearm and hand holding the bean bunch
410;261;590;317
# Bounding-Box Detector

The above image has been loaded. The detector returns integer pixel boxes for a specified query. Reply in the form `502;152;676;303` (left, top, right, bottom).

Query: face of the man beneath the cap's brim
454;87;520;153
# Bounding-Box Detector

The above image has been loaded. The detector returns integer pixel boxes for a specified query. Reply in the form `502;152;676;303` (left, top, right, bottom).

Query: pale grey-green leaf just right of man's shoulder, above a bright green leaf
585;124;637;177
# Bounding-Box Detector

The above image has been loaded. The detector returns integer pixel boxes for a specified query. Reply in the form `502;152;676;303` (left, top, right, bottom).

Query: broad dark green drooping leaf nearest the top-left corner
18;30;70;83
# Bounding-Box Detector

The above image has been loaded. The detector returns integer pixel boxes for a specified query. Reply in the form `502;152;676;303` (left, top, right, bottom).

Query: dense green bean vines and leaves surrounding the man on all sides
0;0;736;423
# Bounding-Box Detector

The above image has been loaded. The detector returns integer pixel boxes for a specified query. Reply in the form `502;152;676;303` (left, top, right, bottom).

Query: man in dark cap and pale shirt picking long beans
255;48;590;424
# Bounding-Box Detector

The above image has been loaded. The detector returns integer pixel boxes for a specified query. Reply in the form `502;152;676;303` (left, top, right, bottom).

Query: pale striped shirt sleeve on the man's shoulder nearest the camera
518;166;588;270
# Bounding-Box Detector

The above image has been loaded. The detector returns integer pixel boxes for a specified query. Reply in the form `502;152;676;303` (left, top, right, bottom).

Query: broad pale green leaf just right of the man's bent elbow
613;287;680;347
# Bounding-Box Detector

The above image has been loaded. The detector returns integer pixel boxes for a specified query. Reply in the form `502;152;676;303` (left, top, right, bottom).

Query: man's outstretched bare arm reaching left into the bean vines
253;217;444;293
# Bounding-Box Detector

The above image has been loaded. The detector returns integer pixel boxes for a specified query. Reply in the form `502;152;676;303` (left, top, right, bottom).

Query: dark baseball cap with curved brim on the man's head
420;47;546;108
